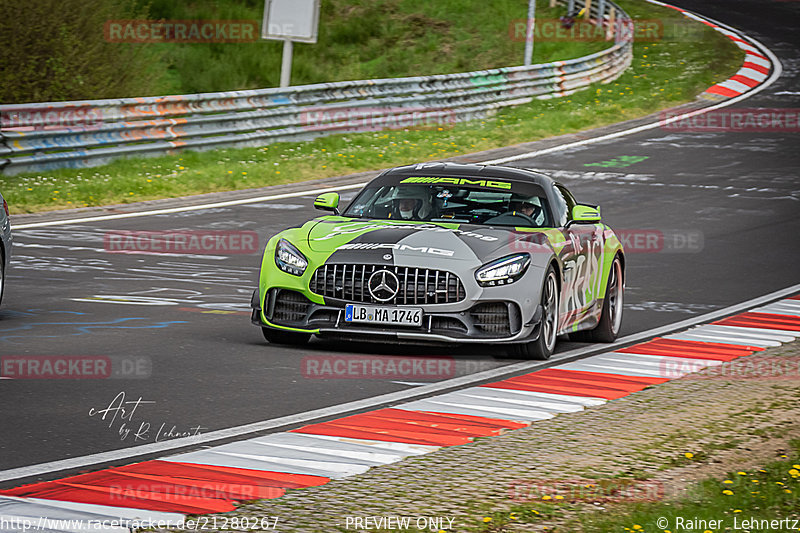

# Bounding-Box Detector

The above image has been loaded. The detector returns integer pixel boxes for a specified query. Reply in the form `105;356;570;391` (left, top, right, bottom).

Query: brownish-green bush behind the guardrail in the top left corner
0;0;160;104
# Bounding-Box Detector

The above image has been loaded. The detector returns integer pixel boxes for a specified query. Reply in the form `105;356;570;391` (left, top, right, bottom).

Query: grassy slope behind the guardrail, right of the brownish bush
145;0;604;96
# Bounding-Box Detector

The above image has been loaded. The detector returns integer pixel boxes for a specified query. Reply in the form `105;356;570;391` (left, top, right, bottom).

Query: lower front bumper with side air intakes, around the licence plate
251;288;542;344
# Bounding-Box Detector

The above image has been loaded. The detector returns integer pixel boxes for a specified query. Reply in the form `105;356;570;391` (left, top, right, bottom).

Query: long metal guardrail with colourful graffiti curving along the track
0;0;633;175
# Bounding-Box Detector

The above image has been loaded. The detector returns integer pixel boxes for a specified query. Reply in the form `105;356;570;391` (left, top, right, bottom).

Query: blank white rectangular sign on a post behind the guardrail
261;0;320;87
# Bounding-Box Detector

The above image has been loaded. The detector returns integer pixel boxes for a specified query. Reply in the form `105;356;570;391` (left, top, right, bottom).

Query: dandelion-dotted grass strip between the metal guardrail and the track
0;0;743;213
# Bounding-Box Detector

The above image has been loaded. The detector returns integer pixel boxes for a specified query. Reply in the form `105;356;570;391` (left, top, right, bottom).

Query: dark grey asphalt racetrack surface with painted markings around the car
0;0;800;482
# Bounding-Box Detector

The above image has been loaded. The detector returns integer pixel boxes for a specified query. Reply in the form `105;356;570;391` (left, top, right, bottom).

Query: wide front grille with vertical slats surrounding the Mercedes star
309;264;467;305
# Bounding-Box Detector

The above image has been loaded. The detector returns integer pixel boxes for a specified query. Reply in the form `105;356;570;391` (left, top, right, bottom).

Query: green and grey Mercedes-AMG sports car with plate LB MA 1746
252;163;625;359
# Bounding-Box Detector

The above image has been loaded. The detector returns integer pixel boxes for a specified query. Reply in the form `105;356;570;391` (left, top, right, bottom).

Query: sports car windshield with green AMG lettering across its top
344;178;552;228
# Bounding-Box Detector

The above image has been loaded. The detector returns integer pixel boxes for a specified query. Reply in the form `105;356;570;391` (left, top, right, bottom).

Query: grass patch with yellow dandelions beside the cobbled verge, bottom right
467;441;800;533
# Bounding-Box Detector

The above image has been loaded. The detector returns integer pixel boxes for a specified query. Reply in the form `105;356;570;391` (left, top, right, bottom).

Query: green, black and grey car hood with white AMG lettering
308;217;552;268
